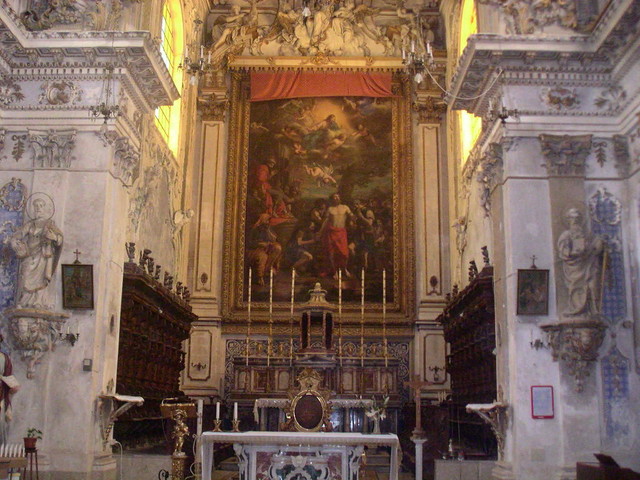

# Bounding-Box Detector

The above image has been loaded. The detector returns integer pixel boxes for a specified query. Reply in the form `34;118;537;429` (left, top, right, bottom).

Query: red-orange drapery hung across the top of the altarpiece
251;71;394;102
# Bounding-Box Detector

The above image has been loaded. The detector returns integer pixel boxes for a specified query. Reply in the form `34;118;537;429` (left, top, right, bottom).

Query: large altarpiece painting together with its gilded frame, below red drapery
222;72;415;326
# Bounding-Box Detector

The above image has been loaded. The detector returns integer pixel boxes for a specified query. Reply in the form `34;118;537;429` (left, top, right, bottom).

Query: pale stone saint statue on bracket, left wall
8;193;63;310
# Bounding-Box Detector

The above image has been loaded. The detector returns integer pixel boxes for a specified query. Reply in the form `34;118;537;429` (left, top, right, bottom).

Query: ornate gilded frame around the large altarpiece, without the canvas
221;71;416;324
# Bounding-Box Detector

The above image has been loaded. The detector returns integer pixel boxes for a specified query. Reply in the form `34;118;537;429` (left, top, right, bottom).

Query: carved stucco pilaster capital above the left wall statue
29;130;76;168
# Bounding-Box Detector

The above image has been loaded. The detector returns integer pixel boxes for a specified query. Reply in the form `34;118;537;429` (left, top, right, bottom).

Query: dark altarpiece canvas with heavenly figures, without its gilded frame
244;97;394;303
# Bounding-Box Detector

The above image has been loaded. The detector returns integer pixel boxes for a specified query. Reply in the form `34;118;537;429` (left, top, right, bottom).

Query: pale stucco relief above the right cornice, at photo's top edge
479;0;578;35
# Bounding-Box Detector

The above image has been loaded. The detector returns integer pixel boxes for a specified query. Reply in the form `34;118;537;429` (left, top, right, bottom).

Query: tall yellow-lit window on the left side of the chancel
156;0;184;154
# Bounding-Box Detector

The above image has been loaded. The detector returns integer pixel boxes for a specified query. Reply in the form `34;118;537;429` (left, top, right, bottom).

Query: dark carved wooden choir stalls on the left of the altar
115;263;198;447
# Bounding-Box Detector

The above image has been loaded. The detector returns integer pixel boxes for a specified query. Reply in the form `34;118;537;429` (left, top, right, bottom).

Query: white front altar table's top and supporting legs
200;432;400;480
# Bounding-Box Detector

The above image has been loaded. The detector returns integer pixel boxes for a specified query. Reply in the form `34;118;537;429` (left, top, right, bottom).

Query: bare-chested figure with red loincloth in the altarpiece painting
321;193;354;277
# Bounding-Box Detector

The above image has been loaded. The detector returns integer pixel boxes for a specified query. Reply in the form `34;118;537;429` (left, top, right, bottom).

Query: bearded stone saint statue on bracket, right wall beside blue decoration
557;208;605;317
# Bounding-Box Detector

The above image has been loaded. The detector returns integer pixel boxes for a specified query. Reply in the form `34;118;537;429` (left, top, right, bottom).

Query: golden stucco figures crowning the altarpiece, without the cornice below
211;0;432;65
